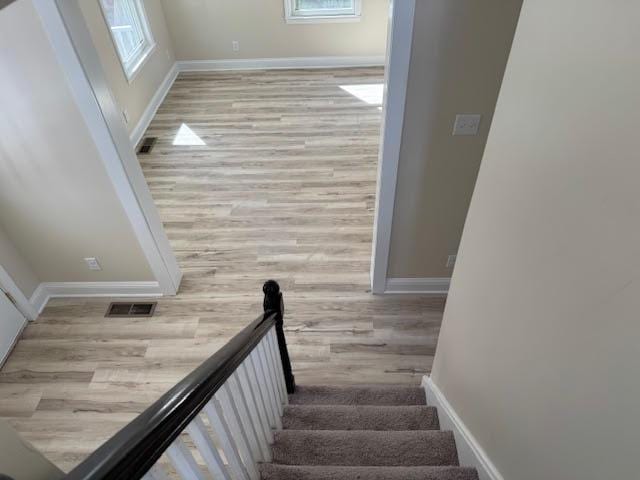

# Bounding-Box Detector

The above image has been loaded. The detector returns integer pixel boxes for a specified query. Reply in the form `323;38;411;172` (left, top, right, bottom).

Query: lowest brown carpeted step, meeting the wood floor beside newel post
289;384;427;405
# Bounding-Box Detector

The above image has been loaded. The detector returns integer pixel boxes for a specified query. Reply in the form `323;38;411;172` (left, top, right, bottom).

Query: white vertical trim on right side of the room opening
371;0;416;294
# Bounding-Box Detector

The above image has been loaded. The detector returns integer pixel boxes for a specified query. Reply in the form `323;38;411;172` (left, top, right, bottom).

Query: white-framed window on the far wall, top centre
284;0;361;23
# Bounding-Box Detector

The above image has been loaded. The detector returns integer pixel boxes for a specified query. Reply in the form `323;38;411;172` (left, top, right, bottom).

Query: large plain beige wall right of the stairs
433;0;640;480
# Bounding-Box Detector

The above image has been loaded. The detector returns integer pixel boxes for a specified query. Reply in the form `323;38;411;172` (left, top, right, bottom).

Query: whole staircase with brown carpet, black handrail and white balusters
64;280;478;480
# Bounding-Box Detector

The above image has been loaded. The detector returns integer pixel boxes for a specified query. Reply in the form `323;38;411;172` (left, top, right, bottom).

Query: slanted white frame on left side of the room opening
33;0;182;295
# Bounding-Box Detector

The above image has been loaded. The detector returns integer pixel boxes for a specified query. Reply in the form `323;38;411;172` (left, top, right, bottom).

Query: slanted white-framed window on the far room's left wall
100;0;155;81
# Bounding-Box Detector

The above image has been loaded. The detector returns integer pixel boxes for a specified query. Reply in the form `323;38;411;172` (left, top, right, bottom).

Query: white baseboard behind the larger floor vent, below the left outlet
30;282;162;313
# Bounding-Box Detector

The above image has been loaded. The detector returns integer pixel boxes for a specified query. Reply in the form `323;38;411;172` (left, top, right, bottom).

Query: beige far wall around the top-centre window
162;0;389;60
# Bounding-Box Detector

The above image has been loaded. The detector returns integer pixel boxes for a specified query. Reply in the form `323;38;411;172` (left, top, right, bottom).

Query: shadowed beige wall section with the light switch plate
388;0;522;278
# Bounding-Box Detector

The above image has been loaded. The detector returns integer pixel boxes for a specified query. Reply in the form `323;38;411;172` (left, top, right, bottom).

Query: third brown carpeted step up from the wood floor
273;430;458;466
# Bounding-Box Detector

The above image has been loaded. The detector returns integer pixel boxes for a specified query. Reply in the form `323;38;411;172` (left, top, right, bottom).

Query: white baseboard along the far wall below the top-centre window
177;55;385;72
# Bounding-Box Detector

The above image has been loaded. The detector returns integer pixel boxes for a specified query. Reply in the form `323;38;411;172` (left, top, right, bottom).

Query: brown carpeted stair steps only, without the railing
260;385;478;480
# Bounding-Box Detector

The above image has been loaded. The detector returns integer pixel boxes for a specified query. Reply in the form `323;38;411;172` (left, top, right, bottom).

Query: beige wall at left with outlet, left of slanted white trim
0;0;153;284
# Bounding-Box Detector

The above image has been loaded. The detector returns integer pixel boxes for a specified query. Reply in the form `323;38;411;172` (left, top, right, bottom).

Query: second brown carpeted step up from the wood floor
282;404;440;430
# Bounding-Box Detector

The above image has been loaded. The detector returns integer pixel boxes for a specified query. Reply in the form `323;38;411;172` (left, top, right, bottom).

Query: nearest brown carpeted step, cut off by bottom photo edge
260;463;478;480
